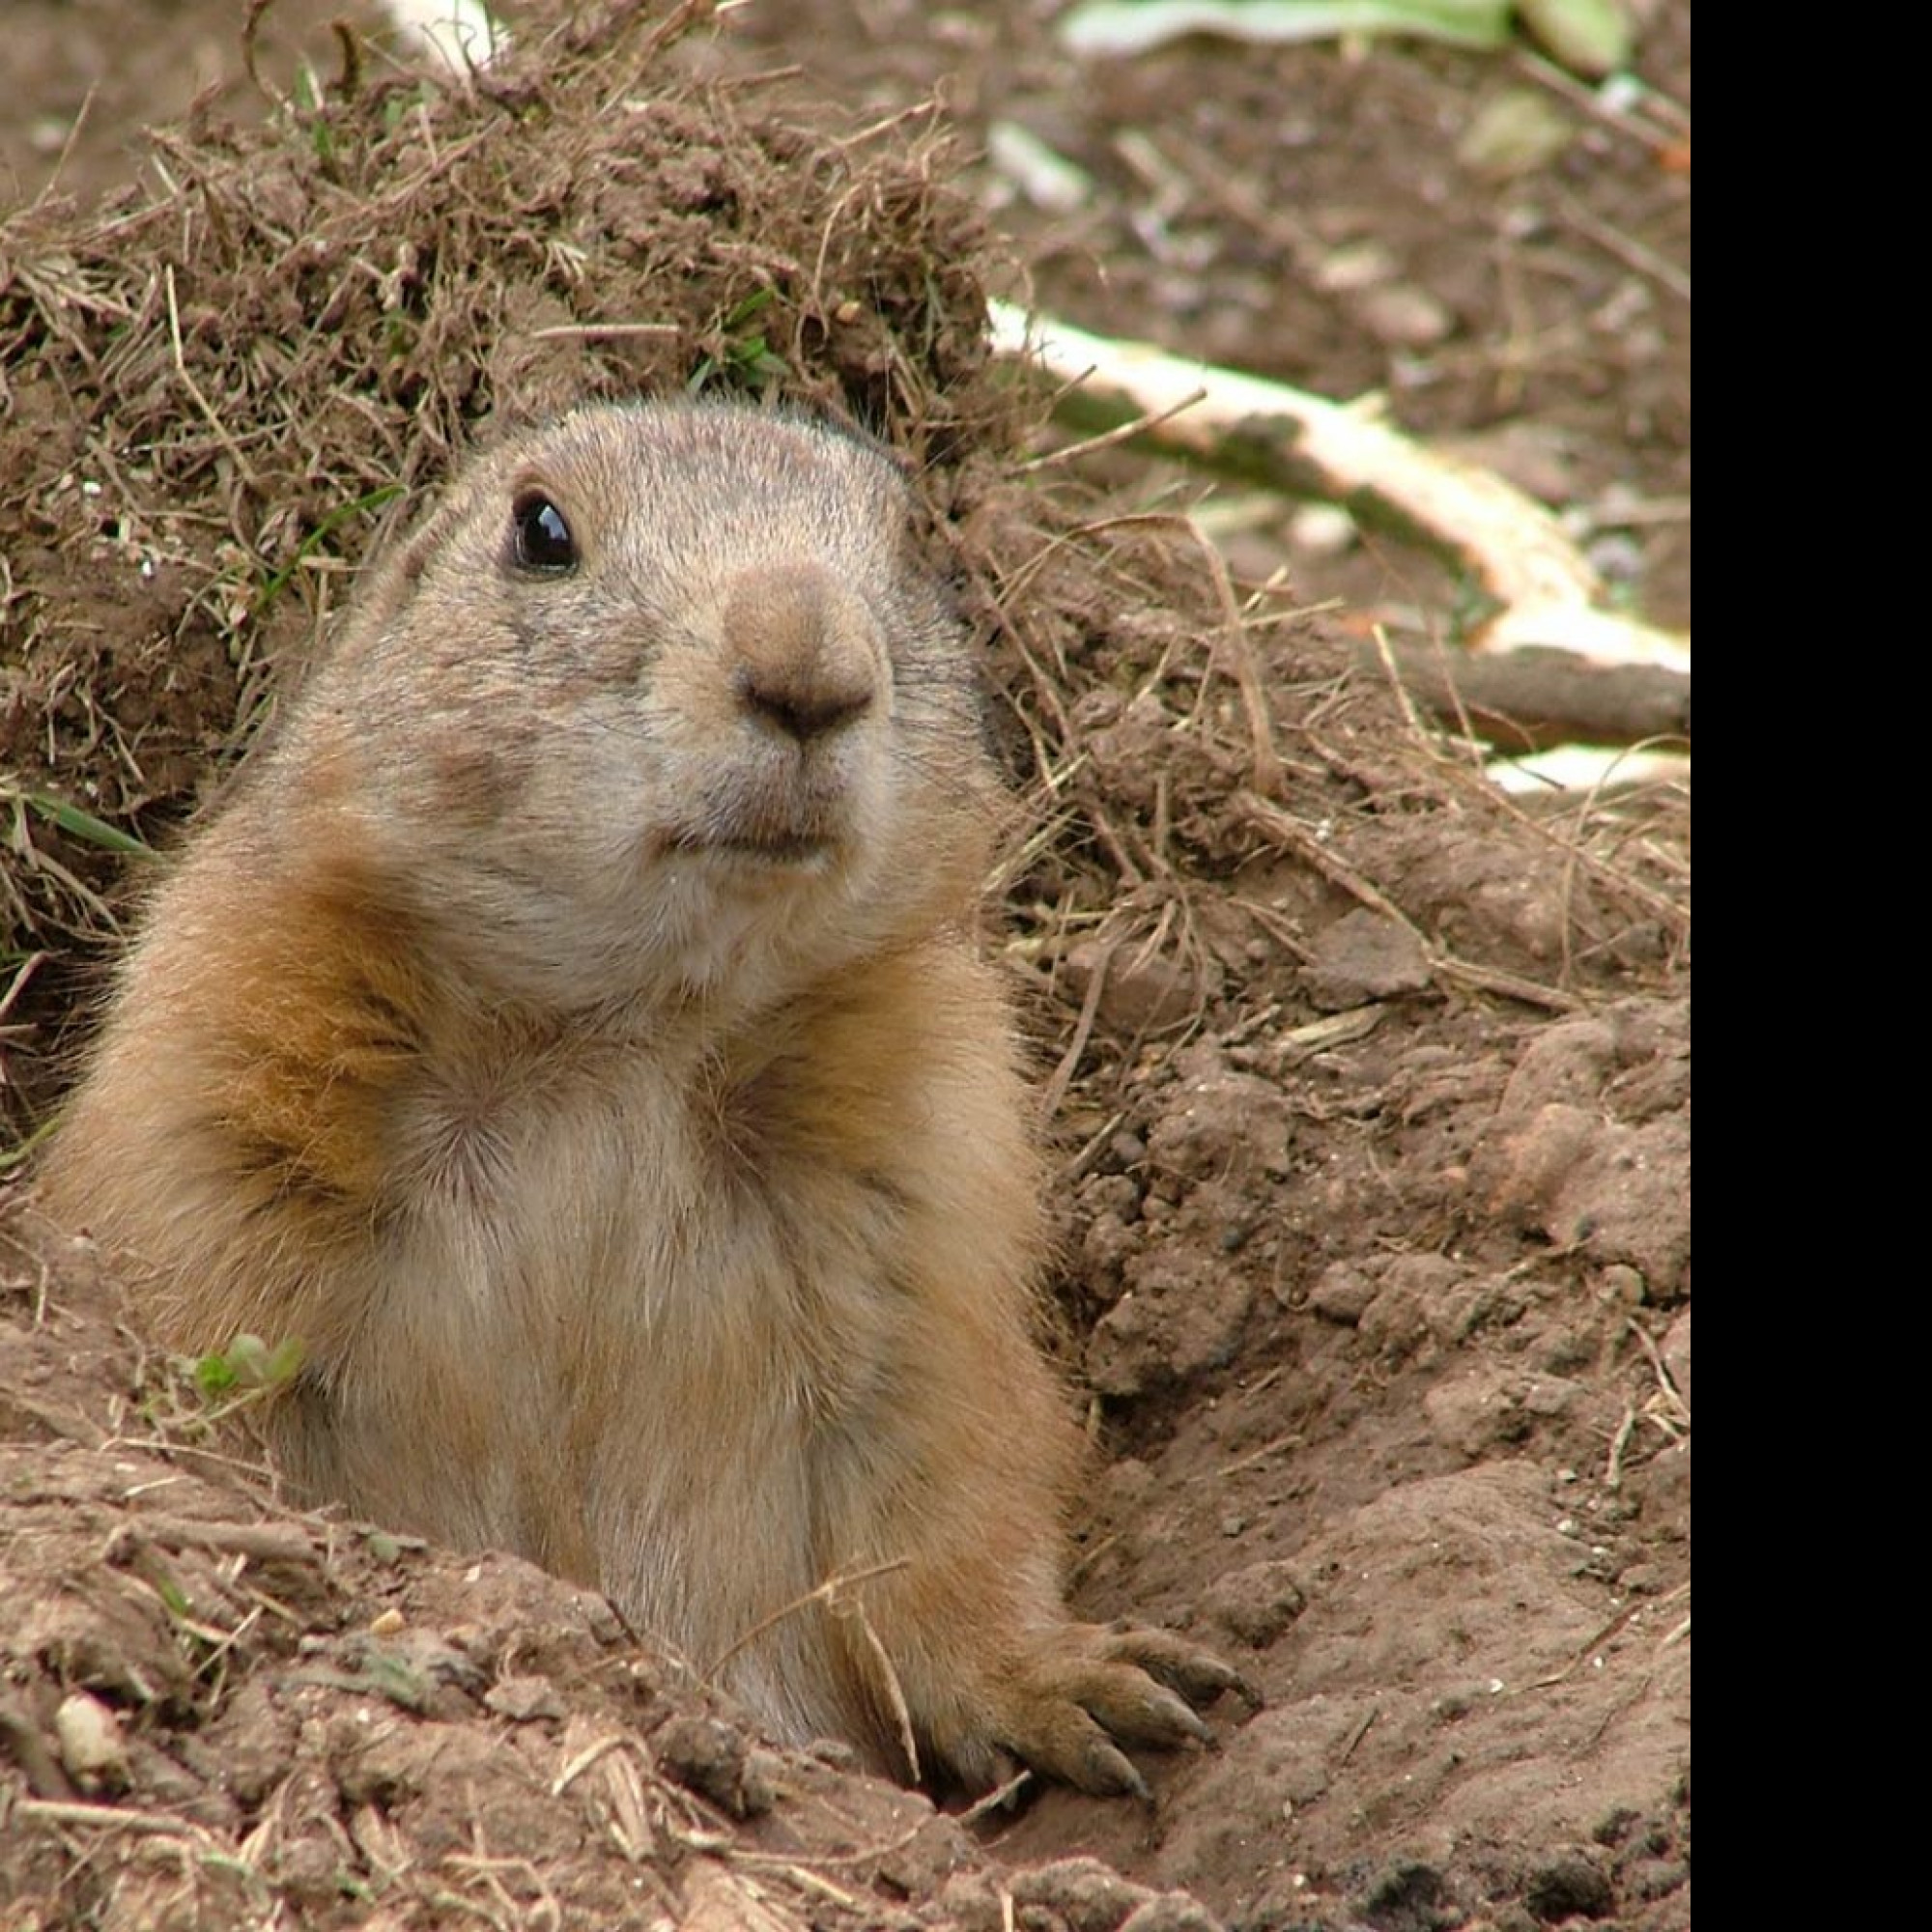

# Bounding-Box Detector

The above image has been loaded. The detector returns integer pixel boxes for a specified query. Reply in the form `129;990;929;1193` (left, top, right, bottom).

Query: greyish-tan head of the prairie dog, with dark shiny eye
261;404;995;1010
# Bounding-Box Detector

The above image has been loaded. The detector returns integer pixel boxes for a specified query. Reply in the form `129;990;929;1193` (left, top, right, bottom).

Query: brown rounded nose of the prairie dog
723;564;879;744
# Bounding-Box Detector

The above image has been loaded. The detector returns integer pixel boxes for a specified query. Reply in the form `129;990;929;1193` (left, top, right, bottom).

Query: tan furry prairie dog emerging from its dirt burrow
48;404;1233;1793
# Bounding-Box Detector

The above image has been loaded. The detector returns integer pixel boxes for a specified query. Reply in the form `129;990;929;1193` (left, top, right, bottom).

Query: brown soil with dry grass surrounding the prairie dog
0;0;1690;1932
